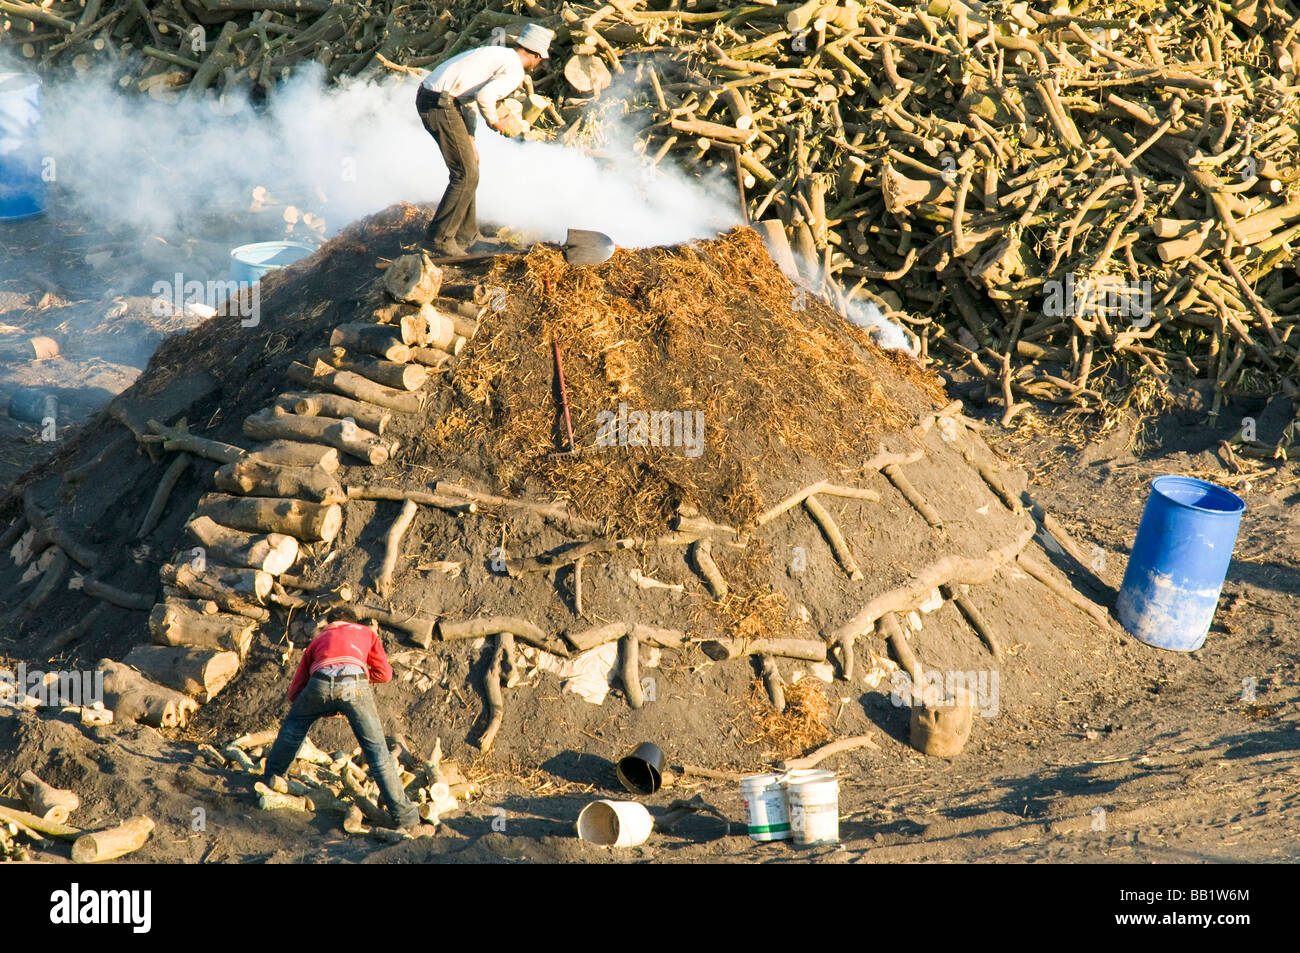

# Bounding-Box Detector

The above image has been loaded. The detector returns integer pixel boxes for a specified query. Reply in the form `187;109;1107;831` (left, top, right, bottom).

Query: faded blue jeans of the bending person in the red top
263;675;410;827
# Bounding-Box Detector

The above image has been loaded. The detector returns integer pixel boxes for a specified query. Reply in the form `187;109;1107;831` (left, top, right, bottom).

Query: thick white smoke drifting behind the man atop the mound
25;54;738;247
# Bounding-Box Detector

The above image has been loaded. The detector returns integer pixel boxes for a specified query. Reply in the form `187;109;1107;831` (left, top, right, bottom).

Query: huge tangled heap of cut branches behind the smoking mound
10;0;1300;452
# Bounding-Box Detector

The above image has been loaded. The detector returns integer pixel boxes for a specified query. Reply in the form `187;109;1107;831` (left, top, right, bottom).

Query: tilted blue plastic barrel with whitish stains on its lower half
1115;476;1245;651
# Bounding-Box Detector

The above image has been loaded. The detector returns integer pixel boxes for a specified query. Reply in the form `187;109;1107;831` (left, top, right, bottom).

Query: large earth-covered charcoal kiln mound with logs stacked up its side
0;205;1119;775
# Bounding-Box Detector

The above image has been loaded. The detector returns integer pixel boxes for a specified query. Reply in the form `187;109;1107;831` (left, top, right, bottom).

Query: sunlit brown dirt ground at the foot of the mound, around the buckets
0;400;1300;863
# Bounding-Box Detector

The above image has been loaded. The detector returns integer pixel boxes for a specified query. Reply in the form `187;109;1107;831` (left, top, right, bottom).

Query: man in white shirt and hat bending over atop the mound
415;23;555;257
